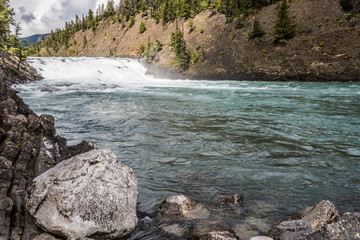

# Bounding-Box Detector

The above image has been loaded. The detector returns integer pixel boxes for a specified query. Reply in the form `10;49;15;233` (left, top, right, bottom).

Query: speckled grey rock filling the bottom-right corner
306;213;360;240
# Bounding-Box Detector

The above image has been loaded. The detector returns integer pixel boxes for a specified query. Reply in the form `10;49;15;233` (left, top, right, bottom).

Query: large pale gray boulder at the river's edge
26;150;138;239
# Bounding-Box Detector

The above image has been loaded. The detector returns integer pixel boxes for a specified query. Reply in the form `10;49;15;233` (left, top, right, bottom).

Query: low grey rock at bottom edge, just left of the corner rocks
270;220;314;240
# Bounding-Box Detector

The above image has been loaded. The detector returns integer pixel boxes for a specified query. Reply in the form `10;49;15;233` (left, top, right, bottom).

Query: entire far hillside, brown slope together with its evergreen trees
32;0;360;80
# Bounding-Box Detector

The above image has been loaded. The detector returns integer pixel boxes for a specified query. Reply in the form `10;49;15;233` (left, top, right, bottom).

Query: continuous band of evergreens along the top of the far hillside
31;0;278;55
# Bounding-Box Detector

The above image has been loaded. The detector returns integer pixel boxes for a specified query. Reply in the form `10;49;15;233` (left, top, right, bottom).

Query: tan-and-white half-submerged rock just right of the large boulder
159;195;210;219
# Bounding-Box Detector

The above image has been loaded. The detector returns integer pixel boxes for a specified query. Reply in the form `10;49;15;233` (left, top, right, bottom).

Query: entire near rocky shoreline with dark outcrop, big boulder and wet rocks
0;58;360;240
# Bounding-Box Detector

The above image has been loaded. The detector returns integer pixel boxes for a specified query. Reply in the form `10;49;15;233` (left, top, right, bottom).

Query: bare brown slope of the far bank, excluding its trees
41;0;360;81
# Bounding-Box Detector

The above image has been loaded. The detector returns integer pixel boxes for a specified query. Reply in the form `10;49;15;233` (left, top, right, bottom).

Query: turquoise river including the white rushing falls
17;58;360;233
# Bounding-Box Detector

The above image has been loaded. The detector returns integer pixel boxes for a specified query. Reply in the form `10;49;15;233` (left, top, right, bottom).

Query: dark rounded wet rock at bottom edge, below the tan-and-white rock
189;224;239;240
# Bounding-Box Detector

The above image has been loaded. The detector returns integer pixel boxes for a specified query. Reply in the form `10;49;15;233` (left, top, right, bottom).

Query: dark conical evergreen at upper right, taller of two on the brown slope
274;0;295;42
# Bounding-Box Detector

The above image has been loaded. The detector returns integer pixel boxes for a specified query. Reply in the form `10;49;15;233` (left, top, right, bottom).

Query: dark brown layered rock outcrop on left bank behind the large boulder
0;81;94;240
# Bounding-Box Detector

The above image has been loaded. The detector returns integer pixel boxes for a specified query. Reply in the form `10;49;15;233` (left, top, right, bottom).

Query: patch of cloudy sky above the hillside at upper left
9;0;111;37
